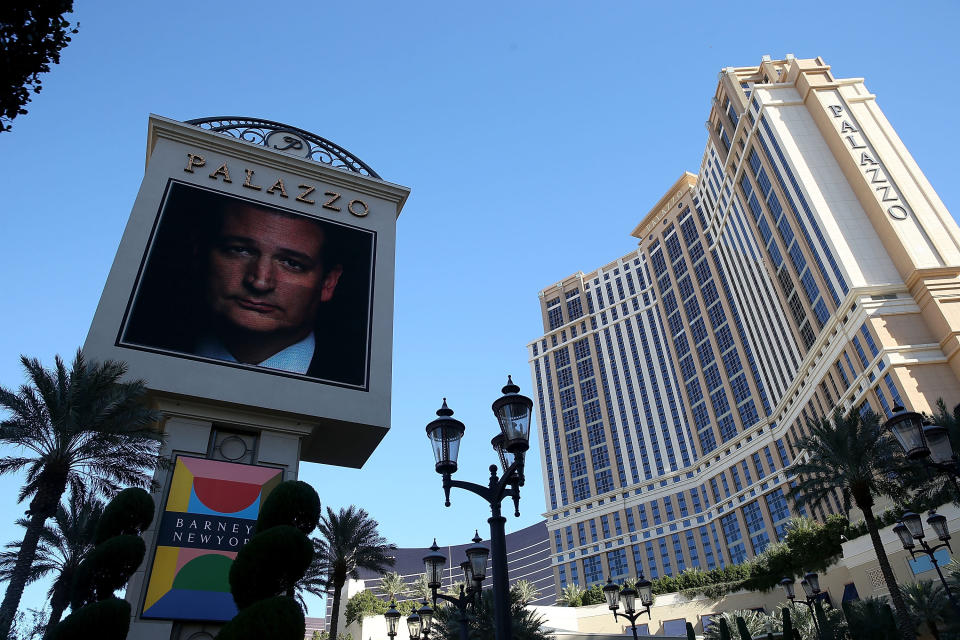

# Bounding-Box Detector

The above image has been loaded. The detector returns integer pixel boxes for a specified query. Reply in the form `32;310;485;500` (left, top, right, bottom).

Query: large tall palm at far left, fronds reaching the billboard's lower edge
0;351;162;638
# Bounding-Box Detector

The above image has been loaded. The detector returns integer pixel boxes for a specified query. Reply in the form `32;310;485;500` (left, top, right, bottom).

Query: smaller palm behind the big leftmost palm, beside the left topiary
0;492;103;636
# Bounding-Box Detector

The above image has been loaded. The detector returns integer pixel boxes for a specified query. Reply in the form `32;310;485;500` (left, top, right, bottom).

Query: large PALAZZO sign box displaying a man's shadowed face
84;116;409;467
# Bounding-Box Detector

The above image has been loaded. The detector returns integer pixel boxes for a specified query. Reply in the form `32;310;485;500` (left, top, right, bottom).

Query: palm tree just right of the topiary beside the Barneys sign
305;505;397;638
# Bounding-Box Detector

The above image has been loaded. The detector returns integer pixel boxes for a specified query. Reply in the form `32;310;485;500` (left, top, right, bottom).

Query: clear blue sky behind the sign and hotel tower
0;1;960;615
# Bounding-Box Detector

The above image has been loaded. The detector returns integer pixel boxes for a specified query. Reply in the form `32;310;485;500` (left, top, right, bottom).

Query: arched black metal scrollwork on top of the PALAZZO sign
187;116;380;178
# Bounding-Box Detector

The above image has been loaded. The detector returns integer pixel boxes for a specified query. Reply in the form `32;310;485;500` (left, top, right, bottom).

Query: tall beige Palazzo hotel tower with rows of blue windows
528;55;960;587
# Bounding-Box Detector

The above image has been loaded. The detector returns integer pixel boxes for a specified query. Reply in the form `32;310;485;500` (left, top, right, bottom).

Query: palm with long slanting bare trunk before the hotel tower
790;410;916;640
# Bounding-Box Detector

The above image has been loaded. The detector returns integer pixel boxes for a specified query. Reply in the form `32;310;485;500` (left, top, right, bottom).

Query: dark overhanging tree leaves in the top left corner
0;0;80;131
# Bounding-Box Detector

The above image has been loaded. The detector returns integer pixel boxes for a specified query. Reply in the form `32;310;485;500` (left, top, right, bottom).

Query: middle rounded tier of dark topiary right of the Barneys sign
230;525;313;608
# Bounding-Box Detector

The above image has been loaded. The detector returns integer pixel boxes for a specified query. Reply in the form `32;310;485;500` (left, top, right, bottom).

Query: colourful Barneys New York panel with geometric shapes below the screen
141;456;283;622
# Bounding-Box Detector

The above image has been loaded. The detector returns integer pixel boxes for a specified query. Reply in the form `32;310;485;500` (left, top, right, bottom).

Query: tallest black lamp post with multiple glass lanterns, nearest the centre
427;376;533;640
